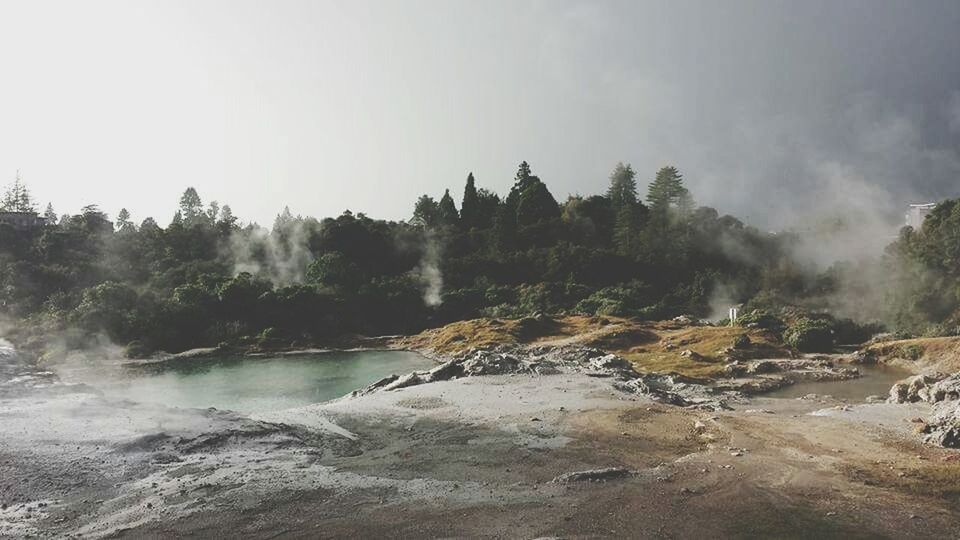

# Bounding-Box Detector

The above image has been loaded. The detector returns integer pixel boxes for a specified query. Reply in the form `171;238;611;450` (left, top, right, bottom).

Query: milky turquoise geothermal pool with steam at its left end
94;351;434;413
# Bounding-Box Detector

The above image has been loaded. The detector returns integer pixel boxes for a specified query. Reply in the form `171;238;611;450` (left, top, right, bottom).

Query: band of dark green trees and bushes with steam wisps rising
0;162;960;354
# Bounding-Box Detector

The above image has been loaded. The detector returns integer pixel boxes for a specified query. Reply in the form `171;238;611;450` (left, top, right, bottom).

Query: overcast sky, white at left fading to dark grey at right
0;0;960;228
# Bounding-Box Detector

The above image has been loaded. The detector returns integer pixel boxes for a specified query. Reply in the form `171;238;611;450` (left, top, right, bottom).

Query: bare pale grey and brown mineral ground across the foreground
0;348;960;538
